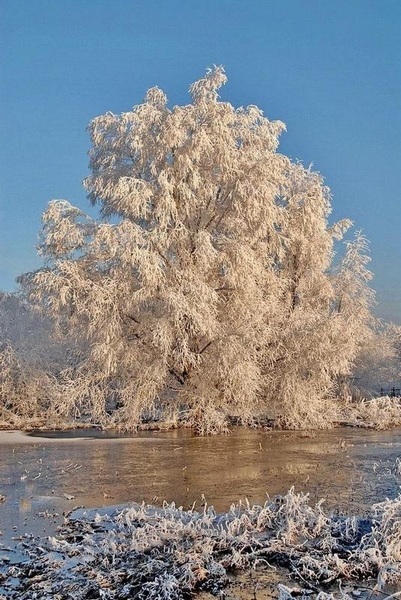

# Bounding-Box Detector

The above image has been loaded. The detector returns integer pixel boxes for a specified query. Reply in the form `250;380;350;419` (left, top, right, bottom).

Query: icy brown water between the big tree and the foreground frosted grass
0;428;401;560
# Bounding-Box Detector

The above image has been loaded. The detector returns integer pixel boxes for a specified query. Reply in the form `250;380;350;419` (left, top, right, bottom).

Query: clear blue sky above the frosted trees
0;0;401;323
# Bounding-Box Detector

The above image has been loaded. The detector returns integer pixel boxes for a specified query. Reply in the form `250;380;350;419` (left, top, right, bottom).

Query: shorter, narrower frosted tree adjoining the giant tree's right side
265;165;351;427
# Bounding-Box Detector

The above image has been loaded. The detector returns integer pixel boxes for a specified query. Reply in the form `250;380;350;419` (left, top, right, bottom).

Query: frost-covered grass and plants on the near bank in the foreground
2;489;401;600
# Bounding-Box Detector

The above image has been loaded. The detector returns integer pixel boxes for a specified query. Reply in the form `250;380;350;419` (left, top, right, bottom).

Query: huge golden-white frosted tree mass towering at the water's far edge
22;67;376;431
